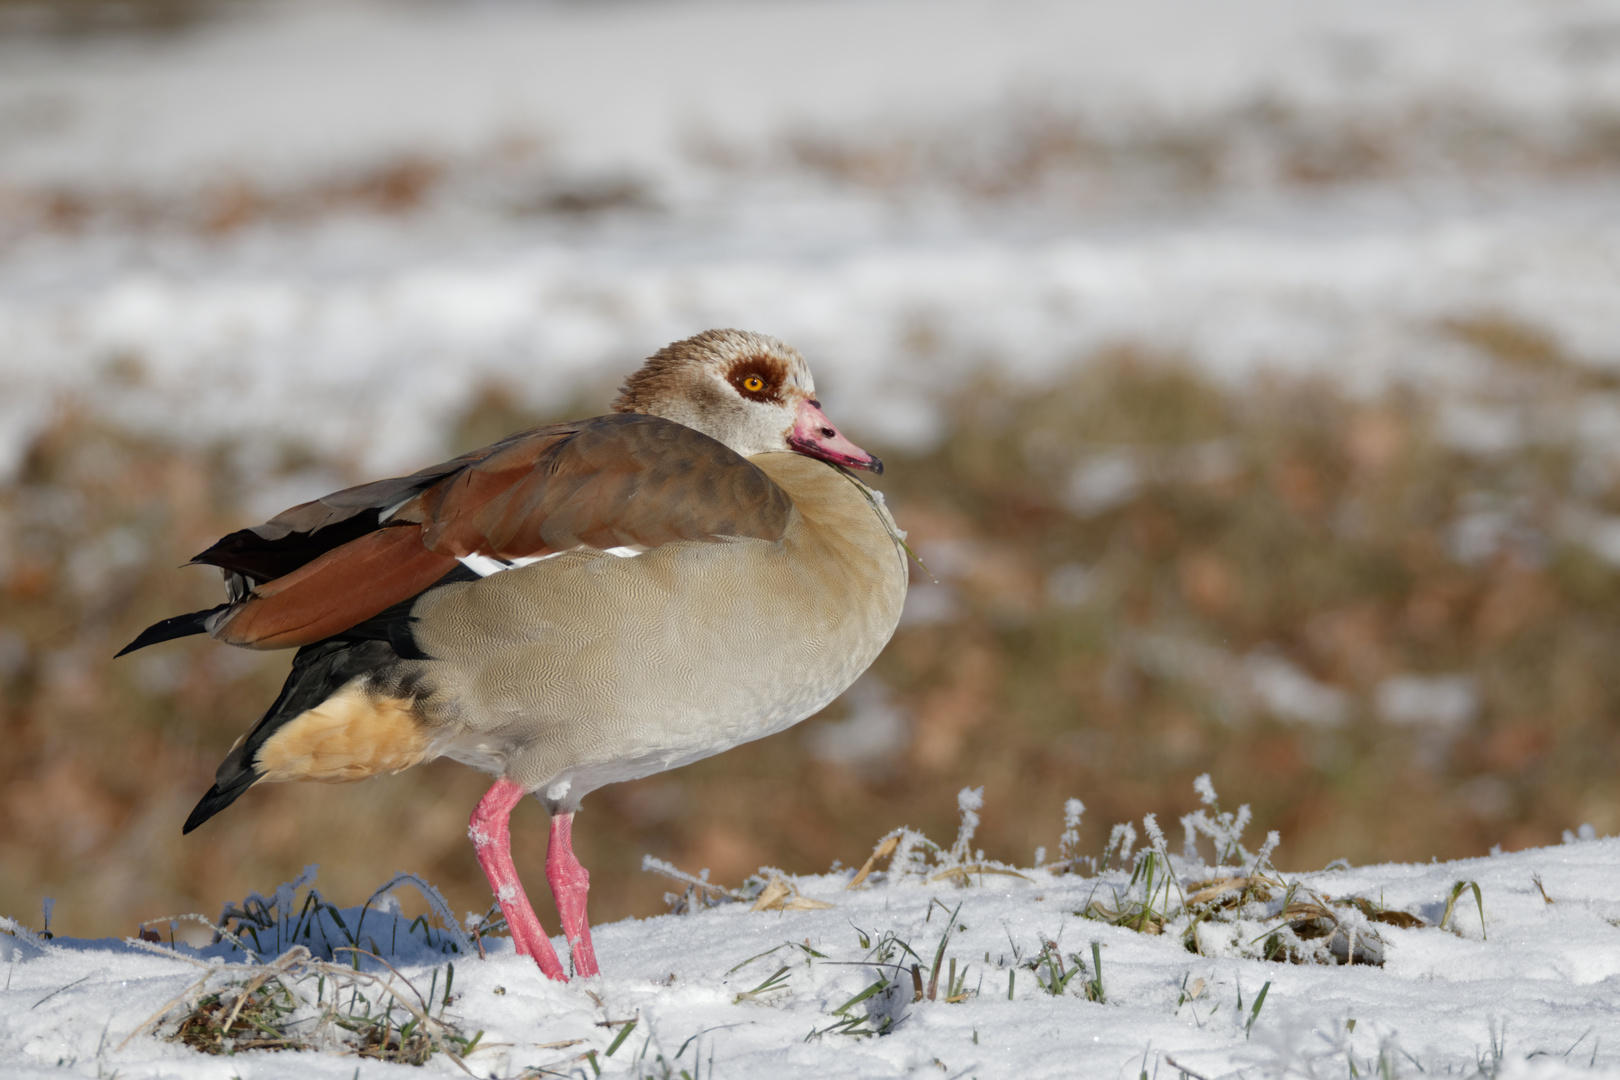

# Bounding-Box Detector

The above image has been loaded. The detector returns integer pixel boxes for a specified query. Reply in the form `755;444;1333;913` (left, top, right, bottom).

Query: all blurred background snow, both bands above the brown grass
0;0;1620;482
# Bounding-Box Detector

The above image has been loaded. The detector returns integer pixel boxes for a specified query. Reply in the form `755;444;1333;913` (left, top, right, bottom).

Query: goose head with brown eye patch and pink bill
612;330;883;473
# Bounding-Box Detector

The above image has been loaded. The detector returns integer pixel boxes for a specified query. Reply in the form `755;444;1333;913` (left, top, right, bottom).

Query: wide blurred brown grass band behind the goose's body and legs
0;331;1620;936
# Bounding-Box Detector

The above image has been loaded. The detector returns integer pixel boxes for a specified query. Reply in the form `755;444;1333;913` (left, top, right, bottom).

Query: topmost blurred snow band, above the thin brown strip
0;0;1620;187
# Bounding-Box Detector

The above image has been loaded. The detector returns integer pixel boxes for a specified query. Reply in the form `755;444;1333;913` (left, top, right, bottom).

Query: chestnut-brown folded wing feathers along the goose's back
198;415;792;648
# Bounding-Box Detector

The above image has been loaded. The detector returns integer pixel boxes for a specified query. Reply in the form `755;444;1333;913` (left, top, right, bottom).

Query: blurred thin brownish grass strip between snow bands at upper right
767;94;1620;206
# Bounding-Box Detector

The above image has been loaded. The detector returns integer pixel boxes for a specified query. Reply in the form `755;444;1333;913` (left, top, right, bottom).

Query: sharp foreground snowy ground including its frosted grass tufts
0;780;1620;1080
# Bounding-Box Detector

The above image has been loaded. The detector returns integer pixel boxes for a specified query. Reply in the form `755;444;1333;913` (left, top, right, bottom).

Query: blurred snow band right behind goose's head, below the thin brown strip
19;191;1620;482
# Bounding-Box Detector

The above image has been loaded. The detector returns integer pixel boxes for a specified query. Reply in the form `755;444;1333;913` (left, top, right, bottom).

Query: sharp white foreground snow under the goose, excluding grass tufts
0;806;1620;1080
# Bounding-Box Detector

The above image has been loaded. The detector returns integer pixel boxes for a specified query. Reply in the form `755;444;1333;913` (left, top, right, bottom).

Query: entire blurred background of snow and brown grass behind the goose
0;0;1620;934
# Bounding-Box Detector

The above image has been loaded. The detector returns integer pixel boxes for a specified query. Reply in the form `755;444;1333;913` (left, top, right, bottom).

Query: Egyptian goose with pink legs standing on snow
120;330;907;980
